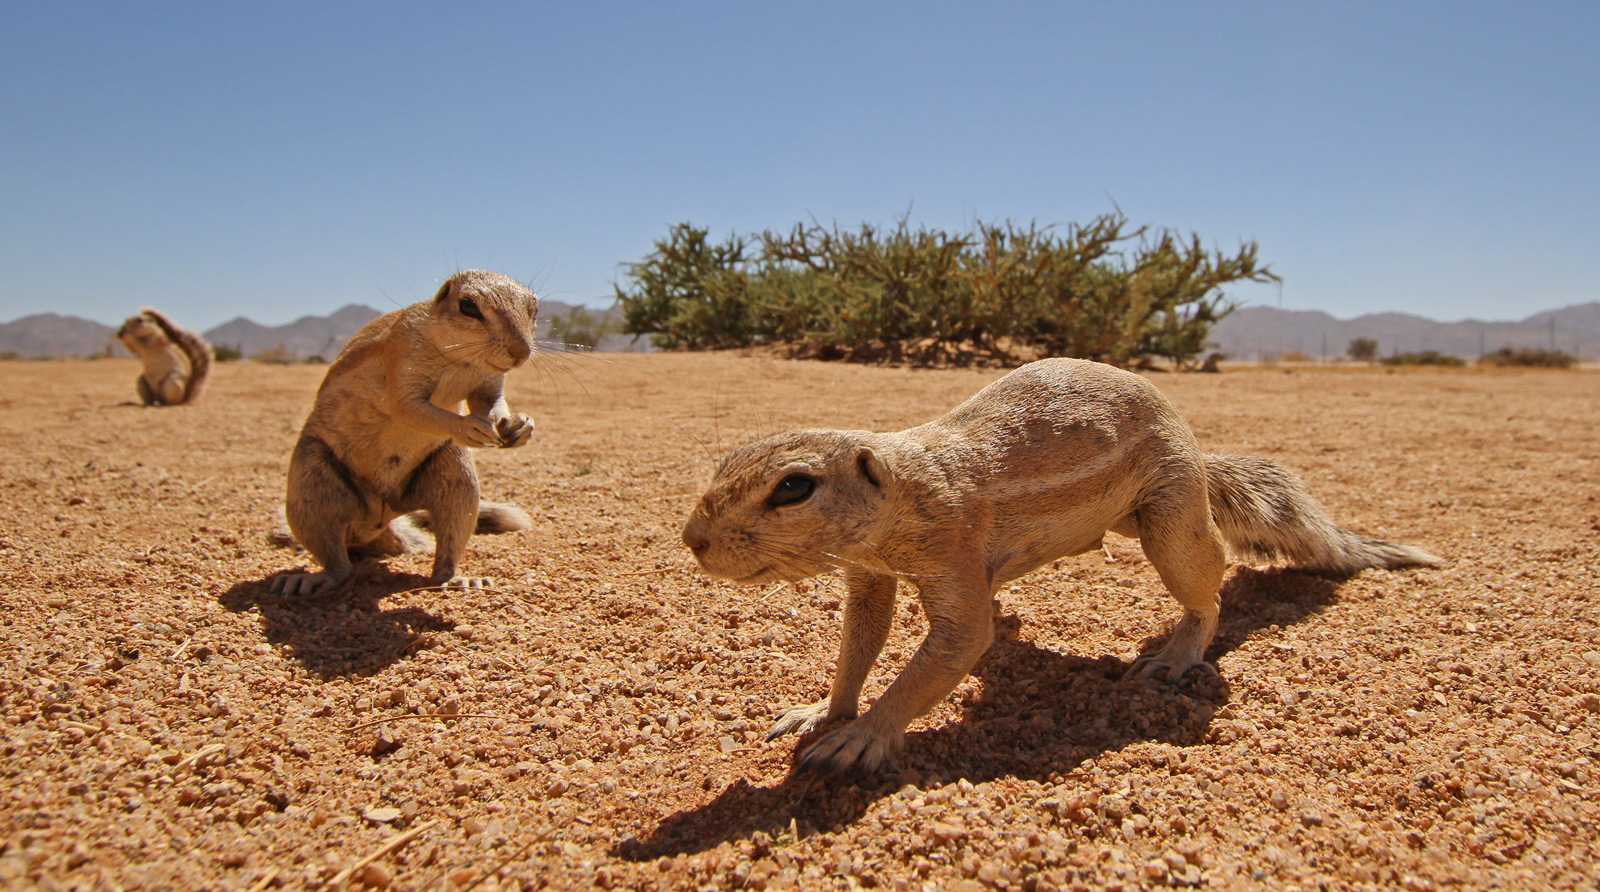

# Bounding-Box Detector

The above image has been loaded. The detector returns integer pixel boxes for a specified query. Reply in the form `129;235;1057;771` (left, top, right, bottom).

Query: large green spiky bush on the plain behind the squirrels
616;214;1278;366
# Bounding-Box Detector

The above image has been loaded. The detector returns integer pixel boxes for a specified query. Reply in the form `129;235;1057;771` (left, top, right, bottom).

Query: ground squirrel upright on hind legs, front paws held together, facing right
272;270;539;595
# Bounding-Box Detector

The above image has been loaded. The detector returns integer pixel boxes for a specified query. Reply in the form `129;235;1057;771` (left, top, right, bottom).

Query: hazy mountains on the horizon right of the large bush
1211;302;1600;360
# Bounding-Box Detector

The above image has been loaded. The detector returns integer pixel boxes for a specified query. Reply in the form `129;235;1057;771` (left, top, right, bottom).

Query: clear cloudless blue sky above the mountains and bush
0;0;1600;328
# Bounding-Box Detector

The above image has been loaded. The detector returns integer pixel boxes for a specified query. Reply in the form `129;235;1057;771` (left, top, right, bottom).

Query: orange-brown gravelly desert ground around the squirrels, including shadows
0;353;1600;892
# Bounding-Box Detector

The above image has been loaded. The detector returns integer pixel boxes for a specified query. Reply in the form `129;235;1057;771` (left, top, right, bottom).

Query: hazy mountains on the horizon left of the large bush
0;301;632;360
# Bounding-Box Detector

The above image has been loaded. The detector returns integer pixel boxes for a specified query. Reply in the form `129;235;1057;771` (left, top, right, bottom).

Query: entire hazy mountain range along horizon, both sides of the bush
0;301;1600;360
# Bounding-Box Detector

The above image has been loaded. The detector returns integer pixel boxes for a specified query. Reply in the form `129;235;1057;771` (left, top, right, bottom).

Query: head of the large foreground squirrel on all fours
683;430;894;583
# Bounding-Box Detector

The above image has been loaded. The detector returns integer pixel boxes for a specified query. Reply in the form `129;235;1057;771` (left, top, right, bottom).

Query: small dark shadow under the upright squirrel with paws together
218;561;454;679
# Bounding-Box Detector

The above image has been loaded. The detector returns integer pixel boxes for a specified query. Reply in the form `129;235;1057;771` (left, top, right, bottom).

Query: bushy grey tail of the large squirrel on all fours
1205;456;1442;574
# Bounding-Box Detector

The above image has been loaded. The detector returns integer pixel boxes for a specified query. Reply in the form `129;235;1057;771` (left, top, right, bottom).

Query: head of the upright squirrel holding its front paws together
426;270;539;374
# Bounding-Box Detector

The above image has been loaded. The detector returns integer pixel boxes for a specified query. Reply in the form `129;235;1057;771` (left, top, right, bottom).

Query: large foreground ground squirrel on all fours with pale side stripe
683;360;1438;772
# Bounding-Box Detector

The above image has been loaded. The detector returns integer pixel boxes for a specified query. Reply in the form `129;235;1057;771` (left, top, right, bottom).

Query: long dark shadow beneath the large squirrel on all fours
611;567;1339;860
